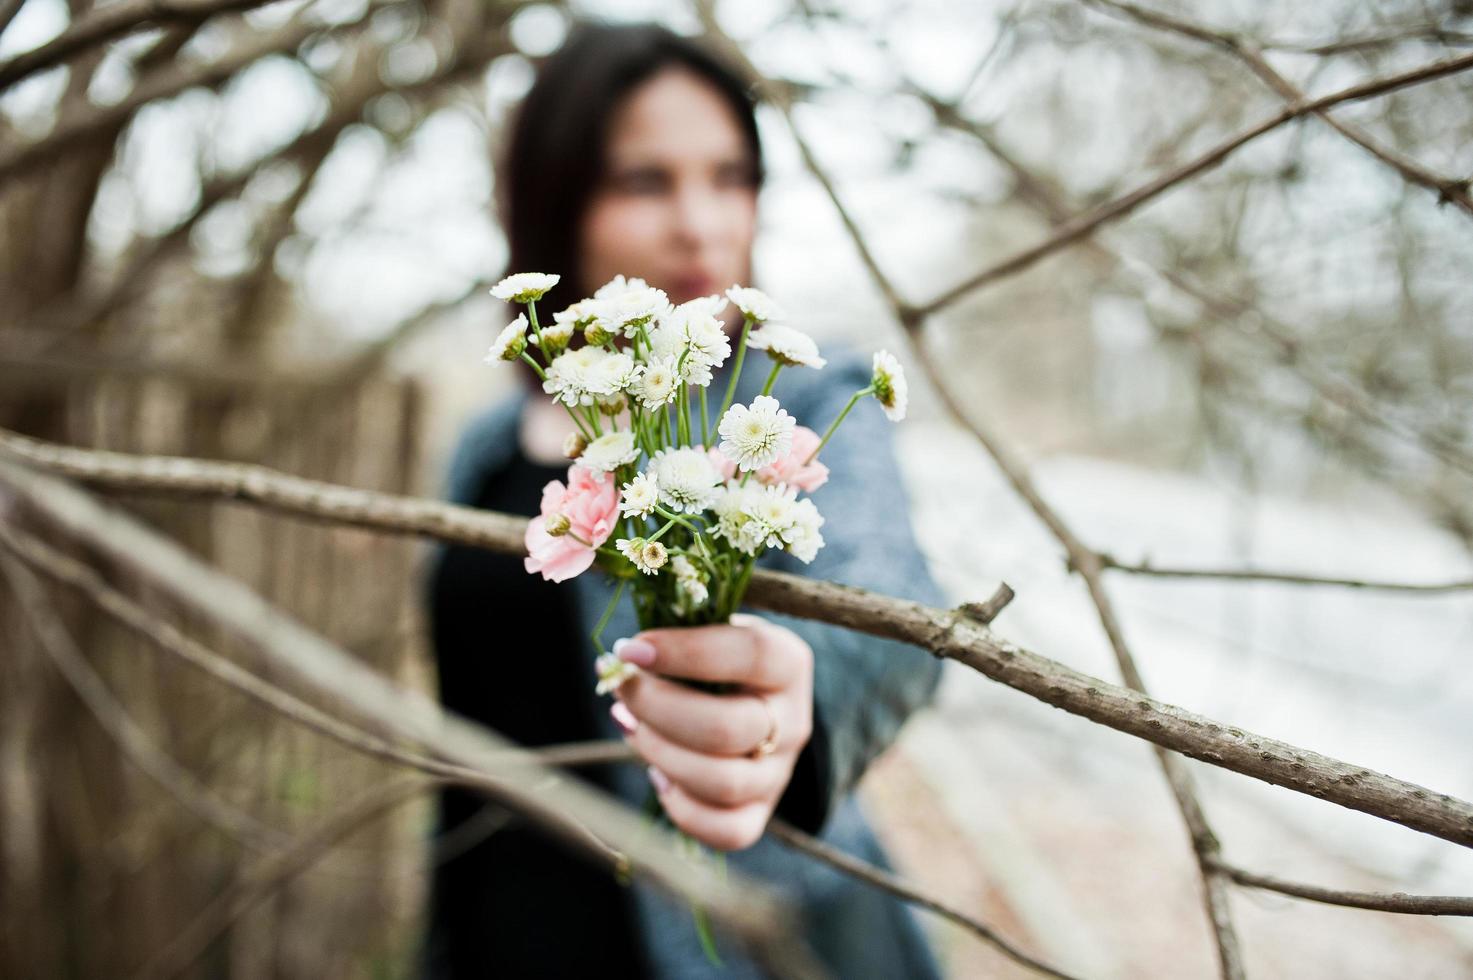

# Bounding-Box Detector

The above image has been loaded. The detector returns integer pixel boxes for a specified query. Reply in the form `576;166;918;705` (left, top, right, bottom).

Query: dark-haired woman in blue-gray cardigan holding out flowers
427;25;940;980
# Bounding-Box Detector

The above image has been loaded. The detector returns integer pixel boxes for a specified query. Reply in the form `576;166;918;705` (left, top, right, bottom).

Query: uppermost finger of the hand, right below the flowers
616;616;812;691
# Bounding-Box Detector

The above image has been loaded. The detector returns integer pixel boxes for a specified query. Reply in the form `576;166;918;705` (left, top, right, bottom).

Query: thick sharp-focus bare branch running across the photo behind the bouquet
0;430;1473;846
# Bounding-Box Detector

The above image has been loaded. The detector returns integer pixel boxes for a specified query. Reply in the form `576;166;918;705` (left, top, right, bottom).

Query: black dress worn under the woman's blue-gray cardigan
426;449;648;980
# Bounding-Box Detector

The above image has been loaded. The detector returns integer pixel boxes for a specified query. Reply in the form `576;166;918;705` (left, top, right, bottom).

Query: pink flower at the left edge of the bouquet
526;466;619;582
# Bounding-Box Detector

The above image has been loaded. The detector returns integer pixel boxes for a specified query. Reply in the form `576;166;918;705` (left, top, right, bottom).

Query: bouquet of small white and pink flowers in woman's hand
486;273;907;953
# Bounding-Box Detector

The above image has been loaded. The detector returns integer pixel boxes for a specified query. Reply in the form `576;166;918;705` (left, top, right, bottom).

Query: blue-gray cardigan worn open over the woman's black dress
436;345;943;980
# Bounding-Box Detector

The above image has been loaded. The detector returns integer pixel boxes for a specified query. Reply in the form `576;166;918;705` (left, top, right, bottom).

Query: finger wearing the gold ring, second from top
614;673;777;756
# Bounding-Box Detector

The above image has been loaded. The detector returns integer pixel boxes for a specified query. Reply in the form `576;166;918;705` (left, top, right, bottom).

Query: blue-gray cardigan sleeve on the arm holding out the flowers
760;352;946;833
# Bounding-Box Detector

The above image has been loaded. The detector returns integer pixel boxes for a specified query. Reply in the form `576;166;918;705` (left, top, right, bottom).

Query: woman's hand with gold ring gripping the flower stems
610;613;813;850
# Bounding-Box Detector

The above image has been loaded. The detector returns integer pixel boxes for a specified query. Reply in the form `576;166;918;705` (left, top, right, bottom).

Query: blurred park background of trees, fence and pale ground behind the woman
0;0;1473;977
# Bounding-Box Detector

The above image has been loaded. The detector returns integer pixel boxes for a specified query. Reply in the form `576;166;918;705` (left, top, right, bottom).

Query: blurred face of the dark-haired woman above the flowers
579;68;757;304
